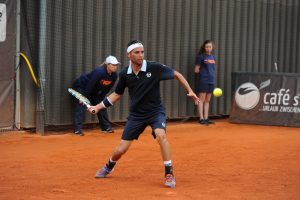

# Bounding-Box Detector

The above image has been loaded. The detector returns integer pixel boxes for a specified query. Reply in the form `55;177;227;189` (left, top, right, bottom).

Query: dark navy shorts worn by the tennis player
122;112;166;140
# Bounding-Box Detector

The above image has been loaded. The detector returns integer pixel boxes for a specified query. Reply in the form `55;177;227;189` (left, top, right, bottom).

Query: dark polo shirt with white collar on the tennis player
115;60;174;118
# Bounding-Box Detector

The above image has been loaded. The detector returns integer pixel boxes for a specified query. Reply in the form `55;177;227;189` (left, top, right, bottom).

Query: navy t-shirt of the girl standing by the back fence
196;54;216;84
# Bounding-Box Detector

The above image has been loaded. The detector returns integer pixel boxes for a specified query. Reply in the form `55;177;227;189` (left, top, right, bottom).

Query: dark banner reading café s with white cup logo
229;73;300;127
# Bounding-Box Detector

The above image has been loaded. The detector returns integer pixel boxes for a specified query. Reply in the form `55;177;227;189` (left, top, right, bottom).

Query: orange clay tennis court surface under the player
0;119;300;200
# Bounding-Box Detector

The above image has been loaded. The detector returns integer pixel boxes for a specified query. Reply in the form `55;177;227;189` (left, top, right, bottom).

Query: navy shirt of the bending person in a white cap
75;66;118;98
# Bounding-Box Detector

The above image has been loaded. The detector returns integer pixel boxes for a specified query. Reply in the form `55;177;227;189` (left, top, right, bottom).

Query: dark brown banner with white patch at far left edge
0;0;16;128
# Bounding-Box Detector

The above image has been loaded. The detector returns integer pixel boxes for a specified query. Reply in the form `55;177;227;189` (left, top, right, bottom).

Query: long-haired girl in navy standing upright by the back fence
195;40;216;125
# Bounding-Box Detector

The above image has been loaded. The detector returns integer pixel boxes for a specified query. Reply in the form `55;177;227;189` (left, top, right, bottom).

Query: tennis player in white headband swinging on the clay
89;40;199;188
